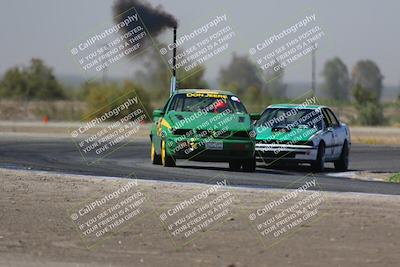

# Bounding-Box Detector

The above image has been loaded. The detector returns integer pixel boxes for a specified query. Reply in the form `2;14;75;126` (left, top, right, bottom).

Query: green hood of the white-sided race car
256;126;319;142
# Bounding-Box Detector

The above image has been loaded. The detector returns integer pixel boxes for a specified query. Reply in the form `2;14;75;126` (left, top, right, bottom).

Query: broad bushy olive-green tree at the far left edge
0;58;65;100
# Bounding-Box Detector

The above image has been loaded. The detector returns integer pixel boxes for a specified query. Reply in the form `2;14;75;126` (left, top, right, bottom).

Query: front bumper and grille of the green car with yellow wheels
167;138;255;162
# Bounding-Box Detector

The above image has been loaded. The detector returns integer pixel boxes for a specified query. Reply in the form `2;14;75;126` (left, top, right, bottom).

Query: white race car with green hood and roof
255;104;351;171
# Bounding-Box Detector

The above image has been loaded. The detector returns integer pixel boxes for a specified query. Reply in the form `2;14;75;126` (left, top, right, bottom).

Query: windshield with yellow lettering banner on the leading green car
169;93;247;113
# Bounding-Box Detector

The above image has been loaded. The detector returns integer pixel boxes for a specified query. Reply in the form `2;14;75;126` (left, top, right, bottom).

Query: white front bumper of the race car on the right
256;143;318;163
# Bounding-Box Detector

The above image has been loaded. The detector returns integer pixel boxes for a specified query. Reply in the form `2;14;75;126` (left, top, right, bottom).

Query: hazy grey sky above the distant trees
0;0;400;85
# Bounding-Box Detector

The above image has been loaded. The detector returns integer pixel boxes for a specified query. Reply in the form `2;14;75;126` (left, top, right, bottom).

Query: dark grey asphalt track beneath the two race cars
0;138;400;195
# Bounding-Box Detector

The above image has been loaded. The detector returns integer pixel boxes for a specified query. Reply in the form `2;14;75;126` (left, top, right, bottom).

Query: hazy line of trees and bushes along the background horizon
0;54;400;125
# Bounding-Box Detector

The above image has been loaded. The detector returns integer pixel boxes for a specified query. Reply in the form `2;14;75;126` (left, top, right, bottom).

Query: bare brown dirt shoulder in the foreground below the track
0;169;400;266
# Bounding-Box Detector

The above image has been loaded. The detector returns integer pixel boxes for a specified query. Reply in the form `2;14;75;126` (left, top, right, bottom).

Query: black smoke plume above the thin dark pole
113;0;178;37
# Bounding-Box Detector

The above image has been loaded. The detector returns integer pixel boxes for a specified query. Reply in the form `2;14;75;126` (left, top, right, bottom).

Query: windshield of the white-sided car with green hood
256;108;323;129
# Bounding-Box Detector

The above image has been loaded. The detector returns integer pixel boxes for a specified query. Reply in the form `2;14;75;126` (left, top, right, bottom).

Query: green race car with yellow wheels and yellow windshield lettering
150;89;256;172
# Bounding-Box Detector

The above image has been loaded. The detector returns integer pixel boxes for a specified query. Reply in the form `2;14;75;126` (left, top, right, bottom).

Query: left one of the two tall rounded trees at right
322;57;350;101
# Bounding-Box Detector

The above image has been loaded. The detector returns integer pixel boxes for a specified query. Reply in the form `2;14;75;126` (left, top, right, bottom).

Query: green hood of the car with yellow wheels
166;111;252;131
